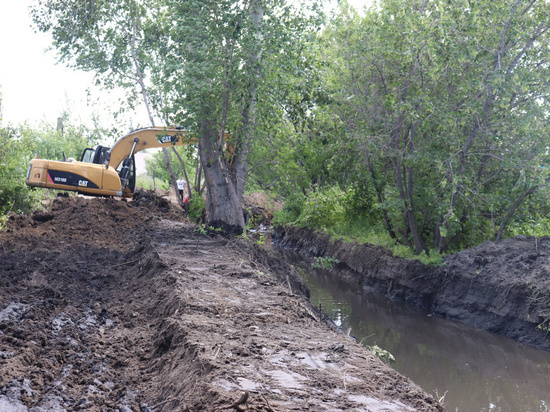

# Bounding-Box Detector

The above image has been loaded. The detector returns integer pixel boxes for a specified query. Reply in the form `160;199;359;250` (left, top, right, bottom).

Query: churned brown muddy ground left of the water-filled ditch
0;194;443;412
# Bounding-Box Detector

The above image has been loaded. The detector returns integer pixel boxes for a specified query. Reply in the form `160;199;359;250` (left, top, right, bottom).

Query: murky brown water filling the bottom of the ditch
279;249;550;412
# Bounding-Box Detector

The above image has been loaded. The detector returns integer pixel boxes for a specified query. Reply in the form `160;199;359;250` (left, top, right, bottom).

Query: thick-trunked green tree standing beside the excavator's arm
158;0;324;232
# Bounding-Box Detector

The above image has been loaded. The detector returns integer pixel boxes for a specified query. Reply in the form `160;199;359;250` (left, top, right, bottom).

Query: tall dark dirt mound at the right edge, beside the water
433;236;550;350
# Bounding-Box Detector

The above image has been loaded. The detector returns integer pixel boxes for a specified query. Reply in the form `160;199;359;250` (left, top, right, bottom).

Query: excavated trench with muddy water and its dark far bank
274;228;550;412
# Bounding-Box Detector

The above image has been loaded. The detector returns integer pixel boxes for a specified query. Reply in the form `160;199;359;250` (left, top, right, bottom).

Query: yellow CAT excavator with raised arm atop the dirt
26;127;197;197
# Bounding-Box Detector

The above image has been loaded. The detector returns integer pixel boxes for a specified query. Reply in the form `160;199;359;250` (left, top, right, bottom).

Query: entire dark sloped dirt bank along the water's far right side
274;228;550;350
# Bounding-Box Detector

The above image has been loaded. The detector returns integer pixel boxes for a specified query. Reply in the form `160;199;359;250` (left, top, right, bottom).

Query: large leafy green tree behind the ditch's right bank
324;0;550;253
